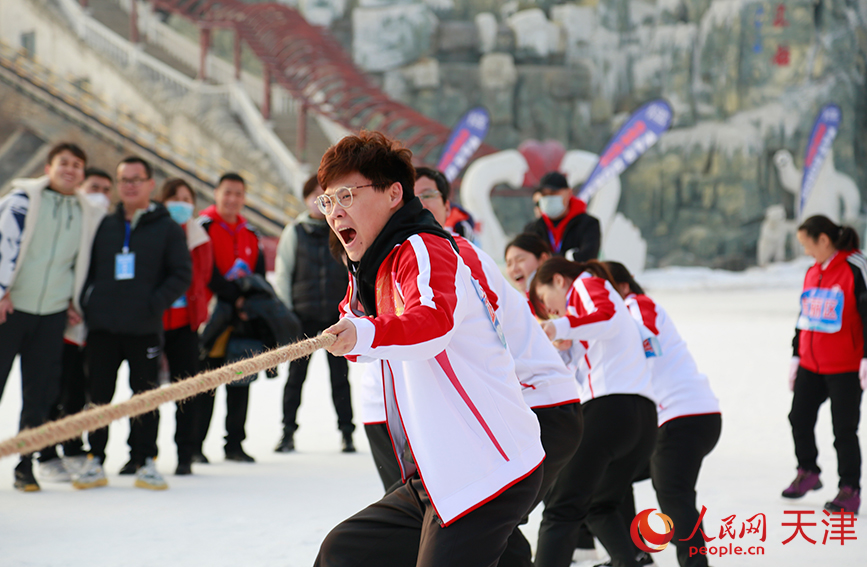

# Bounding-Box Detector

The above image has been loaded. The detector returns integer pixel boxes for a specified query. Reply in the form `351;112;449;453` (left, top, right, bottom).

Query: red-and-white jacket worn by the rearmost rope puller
624;293;720;426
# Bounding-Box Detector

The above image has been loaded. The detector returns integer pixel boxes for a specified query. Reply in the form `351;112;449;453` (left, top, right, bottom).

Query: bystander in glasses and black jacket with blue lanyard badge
73;157;192;490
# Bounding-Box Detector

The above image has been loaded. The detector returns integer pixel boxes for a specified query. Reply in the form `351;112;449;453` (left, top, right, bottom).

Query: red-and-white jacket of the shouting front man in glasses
340;234;545;526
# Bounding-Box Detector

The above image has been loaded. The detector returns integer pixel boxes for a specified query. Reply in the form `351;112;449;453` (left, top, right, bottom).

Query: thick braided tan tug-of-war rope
0;334;336;459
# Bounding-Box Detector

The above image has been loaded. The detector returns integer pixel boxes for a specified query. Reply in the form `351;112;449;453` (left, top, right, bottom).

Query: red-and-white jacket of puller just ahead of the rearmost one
552;272;655;403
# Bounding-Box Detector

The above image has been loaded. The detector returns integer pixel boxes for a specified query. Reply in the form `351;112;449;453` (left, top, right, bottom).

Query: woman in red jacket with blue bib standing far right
783;215;867;514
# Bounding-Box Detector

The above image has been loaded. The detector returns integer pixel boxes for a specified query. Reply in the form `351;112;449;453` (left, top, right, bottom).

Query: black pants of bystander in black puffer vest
283;319;355;433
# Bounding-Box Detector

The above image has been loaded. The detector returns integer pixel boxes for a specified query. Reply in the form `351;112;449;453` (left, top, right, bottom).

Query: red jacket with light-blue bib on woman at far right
792;250;867;374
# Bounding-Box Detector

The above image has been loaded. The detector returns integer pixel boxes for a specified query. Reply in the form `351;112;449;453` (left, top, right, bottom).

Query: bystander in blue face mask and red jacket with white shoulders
158;178;214;475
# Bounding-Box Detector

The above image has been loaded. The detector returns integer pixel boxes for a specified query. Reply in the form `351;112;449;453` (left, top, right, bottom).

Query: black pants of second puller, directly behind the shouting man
364;403;584;567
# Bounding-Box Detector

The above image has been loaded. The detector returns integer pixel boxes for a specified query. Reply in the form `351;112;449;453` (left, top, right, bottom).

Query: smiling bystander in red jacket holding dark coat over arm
193;173;265;463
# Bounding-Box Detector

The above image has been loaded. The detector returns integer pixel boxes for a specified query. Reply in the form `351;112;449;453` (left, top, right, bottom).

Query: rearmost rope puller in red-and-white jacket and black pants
605;262;722;567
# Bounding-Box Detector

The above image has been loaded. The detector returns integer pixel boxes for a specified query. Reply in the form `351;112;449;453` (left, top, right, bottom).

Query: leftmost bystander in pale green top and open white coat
0;143;103;492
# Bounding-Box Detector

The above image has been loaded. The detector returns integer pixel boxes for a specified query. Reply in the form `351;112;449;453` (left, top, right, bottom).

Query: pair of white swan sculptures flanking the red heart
461;150;647;274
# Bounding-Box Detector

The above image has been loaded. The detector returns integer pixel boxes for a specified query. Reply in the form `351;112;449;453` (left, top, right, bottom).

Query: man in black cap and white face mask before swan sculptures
524;171;602;262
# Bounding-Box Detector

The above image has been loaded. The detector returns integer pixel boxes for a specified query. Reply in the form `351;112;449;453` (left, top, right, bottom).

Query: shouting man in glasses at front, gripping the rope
315;132;544;567
